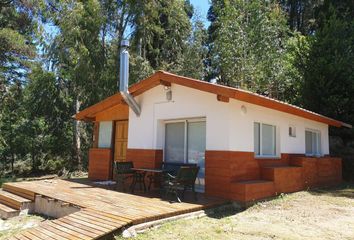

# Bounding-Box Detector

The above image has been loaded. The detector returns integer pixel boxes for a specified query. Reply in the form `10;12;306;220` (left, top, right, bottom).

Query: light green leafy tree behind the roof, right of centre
210;0;288;98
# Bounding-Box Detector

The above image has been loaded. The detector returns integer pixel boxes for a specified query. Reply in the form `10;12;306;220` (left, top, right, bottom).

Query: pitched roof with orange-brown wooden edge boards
74;71;351;128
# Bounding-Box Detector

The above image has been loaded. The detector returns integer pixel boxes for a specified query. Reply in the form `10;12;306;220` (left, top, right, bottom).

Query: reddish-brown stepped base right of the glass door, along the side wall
205;151;342;203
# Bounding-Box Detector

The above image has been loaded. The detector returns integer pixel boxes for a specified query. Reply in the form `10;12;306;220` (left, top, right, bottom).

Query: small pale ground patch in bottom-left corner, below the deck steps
0;215;45;240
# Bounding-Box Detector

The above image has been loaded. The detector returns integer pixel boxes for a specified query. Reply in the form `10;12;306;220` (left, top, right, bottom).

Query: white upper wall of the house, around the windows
128;84;329;154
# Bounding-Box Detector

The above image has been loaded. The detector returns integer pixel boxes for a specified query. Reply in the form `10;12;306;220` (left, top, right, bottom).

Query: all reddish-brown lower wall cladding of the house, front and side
89;149;342;203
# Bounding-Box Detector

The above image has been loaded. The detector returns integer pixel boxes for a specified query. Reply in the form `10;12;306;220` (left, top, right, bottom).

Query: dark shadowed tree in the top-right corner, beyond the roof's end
302;0;354;123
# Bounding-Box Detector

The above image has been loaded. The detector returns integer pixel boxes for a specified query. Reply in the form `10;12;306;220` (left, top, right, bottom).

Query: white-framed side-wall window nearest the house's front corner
254;122;276;157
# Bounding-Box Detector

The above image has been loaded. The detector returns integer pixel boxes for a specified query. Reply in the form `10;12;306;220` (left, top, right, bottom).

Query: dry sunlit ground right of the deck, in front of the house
116;184;354;240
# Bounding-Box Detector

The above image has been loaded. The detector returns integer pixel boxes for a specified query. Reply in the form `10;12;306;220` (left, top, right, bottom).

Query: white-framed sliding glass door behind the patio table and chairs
164;119;206;192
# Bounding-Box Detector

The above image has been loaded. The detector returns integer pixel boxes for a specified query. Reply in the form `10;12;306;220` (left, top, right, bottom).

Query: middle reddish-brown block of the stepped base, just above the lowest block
261;166;303;194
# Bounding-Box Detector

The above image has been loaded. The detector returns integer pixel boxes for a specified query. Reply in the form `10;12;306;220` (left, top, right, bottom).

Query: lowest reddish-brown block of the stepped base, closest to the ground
232;180;276;202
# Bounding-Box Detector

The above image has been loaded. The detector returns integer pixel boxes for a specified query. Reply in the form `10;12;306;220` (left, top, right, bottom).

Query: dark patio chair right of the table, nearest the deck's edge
163;166;199;202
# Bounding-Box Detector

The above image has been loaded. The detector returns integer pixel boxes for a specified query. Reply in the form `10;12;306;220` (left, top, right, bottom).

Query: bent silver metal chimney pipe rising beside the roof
119;40;141;117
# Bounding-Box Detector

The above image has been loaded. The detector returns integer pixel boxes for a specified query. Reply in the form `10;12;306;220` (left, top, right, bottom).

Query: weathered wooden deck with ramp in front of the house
3;179;225;240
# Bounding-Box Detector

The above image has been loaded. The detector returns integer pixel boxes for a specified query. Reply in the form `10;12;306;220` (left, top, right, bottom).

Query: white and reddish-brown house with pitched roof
75;42;351;202
